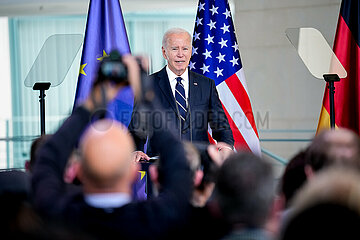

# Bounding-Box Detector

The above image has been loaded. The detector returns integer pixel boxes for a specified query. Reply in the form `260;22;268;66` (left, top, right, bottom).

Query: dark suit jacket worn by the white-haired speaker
129;67;234;155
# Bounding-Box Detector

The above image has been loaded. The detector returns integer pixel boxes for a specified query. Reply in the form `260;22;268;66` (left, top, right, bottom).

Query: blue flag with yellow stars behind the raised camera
74;0;133;126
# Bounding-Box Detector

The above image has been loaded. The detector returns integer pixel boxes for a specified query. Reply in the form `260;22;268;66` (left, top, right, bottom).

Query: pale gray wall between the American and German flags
234;0;340;169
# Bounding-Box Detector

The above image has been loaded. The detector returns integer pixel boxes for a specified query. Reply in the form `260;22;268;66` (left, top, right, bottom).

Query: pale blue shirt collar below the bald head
84;193;131;208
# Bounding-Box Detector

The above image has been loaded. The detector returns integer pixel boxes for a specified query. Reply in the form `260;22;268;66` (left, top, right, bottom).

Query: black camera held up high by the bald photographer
94;50;129;85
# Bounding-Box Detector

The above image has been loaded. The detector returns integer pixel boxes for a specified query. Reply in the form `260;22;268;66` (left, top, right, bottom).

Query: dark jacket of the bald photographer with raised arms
32;107;192;239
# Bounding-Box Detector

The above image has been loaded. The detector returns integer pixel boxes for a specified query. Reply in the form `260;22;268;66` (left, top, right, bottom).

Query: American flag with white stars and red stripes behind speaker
193;0;261;154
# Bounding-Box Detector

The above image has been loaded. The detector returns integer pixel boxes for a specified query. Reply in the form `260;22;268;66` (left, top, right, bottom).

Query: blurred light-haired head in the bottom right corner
280;167;360;240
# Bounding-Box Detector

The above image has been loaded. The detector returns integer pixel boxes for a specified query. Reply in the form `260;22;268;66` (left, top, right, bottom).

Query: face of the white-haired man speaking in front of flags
162;33;192;76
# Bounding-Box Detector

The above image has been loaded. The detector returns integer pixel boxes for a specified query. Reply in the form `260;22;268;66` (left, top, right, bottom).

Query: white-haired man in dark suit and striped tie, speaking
129;28;234;159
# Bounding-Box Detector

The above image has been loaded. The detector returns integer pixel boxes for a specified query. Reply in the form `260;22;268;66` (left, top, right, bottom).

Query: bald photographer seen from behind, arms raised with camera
32;54;191;239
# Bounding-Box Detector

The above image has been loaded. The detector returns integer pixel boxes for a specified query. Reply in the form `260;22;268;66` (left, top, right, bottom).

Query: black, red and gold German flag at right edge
317;0;360;134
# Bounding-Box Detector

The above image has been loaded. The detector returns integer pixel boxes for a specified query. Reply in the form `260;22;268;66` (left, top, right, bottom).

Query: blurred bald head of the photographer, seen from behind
80;120;134;190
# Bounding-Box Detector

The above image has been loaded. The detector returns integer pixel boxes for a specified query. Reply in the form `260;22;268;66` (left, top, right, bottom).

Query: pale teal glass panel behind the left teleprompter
8;16;86;168
